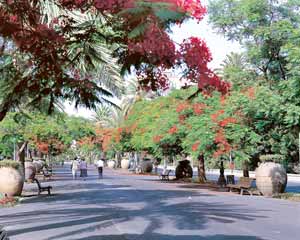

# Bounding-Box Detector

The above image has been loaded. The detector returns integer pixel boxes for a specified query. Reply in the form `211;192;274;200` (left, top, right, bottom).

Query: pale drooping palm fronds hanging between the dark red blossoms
40;0;124;98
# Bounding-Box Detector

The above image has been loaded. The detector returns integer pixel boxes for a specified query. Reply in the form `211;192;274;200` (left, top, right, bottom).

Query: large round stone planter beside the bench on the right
255;162;287;196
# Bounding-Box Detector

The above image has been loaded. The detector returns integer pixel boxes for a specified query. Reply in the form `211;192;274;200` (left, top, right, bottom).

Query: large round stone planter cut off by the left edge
0;167;24;197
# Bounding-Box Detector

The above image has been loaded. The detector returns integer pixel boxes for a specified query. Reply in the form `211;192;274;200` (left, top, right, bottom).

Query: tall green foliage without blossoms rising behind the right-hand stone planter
209;0;300;169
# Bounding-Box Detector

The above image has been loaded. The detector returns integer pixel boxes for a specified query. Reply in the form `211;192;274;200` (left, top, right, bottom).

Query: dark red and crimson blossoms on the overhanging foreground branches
0;0;230;118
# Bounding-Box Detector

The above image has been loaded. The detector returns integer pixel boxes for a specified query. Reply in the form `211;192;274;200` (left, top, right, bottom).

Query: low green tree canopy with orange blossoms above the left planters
0;112;95;156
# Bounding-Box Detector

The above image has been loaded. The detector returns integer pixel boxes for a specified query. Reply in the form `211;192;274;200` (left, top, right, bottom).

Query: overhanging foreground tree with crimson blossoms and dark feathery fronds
0;0;229;120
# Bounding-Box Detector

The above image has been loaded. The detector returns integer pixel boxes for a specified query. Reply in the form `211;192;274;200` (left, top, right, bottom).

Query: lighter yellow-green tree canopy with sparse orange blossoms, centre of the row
119;86;195;158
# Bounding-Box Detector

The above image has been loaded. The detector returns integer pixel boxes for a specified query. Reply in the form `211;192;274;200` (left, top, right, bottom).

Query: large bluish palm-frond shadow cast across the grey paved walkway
0;167;266;240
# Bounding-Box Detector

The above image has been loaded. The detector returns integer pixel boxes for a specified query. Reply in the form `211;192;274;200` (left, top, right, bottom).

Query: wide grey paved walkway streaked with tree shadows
0;168;300;240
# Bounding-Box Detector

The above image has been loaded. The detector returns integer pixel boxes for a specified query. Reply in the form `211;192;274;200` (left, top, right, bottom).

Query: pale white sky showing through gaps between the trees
65;4;241;118
